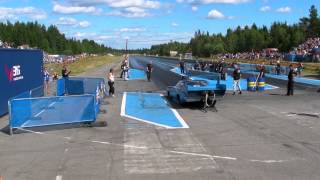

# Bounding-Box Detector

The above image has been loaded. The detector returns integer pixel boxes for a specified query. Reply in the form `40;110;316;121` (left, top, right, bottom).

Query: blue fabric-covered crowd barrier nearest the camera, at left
10;95;97;133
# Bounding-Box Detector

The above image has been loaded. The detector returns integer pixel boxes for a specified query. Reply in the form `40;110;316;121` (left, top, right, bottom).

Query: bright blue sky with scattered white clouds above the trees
0;0;320;49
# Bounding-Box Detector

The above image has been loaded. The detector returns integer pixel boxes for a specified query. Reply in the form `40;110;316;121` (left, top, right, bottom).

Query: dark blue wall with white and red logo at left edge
0;49;43;116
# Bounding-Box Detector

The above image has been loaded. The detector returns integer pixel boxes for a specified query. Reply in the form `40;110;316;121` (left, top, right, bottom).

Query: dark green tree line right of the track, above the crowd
149;6;320;57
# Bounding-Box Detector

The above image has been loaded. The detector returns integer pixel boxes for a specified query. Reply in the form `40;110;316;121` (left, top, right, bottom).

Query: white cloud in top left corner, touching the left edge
0;7;47;20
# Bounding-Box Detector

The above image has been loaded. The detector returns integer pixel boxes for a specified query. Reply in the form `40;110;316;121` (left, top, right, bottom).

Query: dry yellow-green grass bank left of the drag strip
45;56;122;76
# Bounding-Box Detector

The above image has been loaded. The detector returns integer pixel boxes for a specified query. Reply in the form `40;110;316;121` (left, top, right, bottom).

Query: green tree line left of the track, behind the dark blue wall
0;22;112;55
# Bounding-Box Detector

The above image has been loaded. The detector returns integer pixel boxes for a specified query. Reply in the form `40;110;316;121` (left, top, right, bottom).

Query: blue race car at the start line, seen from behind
167;77;226;104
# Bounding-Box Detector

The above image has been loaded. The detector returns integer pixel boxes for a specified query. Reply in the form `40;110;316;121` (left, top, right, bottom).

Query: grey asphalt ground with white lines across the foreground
0;57;320;180
